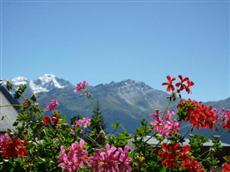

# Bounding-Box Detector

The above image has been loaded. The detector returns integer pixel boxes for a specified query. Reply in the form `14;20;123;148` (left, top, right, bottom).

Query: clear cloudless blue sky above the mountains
1;0;230;101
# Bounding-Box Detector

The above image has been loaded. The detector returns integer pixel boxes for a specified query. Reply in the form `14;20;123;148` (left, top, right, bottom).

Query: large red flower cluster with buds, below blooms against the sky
177;99;218;129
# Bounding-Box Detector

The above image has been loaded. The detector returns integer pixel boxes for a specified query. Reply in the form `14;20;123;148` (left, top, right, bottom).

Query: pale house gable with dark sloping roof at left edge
0;85;19;133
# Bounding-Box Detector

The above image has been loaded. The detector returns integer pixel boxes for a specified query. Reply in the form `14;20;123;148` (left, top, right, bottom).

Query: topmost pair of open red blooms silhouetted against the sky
162;75;194;94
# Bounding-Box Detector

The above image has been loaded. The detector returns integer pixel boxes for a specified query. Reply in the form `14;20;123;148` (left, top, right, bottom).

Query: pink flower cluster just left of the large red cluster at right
150;110;180;137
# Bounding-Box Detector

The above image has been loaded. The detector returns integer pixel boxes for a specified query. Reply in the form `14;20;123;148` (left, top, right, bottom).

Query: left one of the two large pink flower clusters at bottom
58;139;88;172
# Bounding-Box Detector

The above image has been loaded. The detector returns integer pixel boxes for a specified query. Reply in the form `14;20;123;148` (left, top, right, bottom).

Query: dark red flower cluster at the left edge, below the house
0;133;27;159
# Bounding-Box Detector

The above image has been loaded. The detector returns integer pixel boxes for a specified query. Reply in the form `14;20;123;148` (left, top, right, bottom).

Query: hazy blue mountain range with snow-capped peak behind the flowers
9;74;230;141
